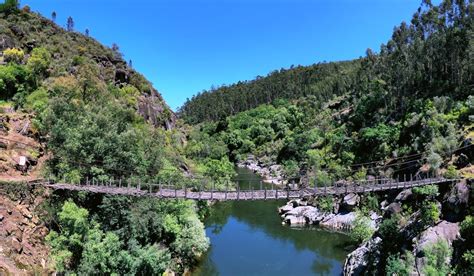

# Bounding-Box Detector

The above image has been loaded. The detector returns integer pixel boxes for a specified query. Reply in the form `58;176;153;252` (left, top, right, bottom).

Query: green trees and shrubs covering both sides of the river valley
0;0;474;275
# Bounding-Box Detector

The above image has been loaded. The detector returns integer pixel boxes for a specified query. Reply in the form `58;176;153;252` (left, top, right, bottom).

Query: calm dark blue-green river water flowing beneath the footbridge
193;168;350;276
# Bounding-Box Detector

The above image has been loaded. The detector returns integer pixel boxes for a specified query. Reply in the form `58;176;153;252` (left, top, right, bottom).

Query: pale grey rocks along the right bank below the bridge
278;181;470;275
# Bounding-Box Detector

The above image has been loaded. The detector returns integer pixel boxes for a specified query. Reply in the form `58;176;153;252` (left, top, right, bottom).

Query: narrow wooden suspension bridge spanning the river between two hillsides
32;177;459;201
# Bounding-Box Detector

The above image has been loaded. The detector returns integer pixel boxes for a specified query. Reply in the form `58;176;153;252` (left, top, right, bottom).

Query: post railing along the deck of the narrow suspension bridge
42;172;457;200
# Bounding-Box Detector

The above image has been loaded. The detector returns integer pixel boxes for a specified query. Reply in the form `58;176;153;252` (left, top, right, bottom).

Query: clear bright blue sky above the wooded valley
21;0;430;109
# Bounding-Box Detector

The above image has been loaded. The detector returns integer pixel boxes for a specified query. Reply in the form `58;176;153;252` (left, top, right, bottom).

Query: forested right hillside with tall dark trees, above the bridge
180;1;474;178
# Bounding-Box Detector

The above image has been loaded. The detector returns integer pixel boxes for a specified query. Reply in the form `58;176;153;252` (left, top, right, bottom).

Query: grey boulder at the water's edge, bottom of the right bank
343;237;382;275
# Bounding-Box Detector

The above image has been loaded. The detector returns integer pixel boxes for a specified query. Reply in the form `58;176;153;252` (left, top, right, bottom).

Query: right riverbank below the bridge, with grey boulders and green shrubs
278;180;472;275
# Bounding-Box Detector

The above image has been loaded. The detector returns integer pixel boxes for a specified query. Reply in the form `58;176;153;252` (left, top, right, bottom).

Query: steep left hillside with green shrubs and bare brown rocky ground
0;0;209;275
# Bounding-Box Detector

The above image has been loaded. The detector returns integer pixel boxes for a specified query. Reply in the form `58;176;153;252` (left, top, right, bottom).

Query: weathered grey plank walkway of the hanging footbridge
35;178;459;201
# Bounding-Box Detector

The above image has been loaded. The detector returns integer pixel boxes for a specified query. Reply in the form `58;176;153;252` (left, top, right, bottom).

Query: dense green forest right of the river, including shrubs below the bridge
179;0;474;275
